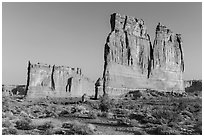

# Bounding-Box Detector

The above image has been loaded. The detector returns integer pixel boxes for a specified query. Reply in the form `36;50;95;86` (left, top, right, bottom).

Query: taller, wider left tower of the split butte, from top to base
103;13;152;94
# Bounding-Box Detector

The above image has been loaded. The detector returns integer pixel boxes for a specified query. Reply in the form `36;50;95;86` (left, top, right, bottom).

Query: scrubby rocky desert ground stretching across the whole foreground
2;90;202;135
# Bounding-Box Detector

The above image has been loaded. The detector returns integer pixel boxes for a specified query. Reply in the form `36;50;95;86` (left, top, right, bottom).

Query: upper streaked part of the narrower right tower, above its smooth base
154;23;184;72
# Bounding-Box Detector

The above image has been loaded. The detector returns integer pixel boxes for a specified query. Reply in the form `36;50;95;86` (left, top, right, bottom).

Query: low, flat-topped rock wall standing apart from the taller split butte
26;62;94;98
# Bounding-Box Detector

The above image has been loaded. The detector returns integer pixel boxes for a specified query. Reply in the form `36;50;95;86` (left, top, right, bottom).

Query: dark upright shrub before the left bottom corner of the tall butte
99;94;111;112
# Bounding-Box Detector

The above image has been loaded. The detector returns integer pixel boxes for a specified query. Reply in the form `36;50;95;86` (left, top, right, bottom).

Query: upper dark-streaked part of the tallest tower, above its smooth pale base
105;13;151;74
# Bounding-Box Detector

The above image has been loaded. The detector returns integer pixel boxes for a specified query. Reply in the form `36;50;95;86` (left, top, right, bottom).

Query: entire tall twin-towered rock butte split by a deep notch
103;13;184;96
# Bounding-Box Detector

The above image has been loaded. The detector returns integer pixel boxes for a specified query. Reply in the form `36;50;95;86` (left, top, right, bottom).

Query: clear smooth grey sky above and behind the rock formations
2;2;202;84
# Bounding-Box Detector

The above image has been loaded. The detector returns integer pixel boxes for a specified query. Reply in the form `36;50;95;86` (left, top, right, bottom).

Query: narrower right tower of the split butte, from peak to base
151;23;184;91
